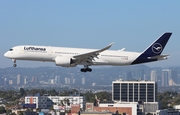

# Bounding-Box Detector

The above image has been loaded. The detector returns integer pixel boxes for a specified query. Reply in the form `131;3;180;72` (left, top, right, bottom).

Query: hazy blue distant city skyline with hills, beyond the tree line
0;66;180;92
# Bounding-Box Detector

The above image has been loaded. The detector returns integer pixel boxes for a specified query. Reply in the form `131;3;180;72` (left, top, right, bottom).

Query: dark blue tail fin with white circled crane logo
132;33;172;64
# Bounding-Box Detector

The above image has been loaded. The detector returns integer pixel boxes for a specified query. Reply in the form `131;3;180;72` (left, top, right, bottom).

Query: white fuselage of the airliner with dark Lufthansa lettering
4;45;141;66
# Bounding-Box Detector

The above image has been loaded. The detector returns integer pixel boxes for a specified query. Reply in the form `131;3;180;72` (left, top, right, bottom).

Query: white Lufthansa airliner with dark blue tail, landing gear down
4;32;172;72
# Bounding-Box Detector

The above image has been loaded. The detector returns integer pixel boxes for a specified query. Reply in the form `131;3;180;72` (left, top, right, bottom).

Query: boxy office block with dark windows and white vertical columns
112;80;157;102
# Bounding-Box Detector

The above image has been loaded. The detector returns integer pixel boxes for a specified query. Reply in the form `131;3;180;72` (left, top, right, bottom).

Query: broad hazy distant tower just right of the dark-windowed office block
162;69;171;86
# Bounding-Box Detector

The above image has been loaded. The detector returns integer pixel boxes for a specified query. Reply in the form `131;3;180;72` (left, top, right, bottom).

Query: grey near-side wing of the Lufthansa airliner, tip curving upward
73;43;113;62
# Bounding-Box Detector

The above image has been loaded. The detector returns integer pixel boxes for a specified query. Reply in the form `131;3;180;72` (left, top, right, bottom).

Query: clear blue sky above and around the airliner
0;0;180;68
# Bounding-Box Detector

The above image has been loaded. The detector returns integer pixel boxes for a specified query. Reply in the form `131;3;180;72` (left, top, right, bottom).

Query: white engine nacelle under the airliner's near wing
55;56;76;67
